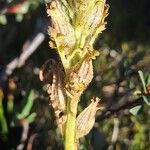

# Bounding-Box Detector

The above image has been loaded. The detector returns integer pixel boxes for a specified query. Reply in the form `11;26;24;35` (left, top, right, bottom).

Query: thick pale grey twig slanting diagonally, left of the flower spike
0;16;49;84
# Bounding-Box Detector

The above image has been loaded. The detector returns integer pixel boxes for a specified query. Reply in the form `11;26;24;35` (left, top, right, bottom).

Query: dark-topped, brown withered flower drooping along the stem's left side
39;59;66;131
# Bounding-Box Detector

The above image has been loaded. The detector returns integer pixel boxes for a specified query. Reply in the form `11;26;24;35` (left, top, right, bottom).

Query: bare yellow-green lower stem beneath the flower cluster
64;100;77;150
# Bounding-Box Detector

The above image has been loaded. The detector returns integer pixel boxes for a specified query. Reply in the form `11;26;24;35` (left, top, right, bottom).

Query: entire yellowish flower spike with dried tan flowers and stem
40;0;109;150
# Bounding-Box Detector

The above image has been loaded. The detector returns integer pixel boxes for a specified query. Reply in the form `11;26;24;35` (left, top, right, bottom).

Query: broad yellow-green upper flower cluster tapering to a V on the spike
47;0;109;73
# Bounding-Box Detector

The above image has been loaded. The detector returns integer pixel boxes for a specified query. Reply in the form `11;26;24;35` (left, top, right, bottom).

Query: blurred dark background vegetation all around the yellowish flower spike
0;0;150;150
